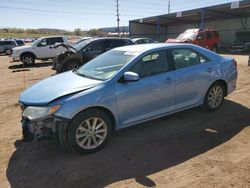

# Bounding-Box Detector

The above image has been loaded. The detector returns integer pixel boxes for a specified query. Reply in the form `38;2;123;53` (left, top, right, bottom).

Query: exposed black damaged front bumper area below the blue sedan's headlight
21;116;70;147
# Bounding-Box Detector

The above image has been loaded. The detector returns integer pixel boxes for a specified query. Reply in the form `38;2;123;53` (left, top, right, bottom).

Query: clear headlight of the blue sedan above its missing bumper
22;105;61;120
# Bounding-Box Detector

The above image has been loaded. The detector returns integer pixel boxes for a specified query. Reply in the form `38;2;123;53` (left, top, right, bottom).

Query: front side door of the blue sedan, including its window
115;50;175;126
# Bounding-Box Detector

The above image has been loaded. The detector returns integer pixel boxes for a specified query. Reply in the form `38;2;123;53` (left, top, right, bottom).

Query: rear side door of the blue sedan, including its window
171;48;215;110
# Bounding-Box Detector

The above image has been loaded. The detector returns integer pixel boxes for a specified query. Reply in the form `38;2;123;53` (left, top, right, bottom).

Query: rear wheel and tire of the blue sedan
203;82;225;111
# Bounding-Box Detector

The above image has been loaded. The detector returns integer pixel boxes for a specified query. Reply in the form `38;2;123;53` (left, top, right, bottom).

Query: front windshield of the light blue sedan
76;50;136;80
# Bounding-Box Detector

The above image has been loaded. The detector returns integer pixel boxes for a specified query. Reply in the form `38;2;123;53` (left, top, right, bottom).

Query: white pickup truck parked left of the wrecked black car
12;36;67;66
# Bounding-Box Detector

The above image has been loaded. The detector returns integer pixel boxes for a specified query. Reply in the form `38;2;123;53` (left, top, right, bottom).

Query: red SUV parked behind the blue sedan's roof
166;29;220;52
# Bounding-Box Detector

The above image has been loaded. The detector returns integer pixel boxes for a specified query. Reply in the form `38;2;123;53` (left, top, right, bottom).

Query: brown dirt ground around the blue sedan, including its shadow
0;53;250;188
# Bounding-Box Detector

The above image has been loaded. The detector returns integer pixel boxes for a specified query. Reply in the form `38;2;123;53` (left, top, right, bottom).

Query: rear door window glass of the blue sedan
171;49;208;69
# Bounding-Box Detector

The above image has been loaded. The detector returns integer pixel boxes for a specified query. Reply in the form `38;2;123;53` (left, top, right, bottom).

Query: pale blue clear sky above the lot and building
0;0;238;30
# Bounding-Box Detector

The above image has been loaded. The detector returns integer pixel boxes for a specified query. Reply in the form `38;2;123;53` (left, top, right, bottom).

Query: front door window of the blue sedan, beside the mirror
129;50;169;78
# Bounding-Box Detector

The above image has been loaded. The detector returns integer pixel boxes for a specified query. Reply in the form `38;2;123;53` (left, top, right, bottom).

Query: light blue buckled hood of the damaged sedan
19;71;102;106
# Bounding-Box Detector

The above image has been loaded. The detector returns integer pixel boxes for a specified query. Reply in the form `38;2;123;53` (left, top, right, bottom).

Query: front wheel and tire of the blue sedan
68;110;112;154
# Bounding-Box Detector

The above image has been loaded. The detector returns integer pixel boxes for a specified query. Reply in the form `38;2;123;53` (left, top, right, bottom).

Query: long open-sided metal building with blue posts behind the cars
129;0;250;46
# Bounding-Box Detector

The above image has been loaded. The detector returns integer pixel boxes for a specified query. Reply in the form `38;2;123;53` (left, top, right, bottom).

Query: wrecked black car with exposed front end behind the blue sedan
52;38;133;73
